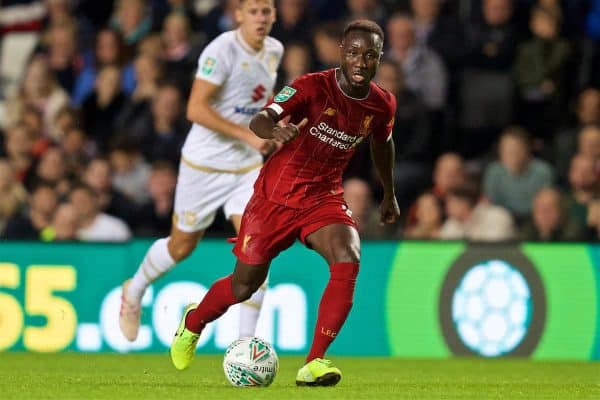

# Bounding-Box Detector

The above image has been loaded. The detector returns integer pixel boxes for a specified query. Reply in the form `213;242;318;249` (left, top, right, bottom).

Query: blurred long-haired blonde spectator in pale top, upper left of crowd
6;55;69;140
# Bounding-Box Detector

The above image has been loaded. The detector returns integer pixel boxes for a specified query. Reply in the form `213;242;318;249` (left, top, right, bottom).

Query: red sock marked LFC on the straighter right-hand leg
306;263;358;362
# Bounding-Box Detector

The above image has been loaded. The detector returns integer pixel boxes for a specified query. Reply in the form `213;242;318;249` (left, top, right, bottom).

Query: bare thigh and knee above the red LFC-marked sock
305;223;360;265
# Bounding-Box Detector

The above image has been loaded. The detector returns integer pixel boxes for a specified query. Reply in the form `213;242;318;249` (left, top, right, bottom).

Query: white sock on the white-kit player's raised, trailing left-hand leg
126;237;175;302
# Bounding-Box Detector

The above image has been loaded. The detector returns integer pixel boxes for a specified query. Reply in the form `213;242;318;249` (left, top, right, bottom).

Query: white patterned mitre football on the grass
223;337;279;387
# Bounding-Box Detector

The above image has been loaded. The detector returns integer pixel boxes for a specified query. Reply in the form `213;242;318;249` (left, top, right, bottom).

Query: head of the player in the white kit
235;0;275;49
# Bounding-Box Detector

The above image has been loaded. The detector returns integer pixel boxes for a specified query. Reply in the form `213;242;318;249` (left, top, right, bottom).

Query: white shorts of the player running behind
173;160;260;232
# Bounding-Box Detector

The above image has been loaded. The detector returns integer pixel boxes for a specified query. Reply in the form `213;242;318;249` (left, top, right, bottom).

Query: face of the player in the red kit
340;30;383;90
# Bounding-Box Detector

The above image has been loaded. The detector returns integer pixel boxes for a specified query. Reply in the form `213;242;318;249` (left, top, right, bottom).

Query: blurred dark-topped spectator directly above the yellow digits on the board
2;183;58;240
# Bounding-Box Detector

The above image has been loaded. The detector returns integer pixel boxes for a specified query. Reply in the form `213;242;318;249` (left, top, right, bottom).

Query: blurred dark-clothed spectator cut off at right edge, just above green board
566;154;599;231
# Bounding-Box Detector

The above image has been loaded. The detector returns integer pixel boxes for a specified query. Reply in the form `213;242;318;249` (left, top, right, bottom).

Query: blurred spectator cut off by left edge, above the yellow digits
0;158;27;232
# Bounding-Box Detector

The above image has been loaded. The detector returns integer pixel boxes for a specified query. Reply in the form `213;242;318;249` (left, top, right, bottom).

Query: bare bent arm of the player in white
187;78;272;153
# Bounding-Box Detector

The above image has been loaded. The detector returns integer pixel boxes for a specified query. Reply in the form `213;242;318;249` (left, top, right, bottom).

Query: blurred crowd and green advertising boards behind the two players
0;0;600;368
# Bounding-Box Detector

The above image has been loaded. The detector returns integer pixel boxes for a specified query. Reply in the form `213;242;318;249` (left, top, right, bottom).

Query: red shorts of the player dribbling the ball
233;193;356;265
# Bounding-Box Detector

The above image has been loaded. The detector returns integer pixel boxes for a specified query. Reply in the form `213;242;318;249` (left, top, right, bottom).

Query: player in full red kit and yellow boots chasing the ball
171;20;400;386
